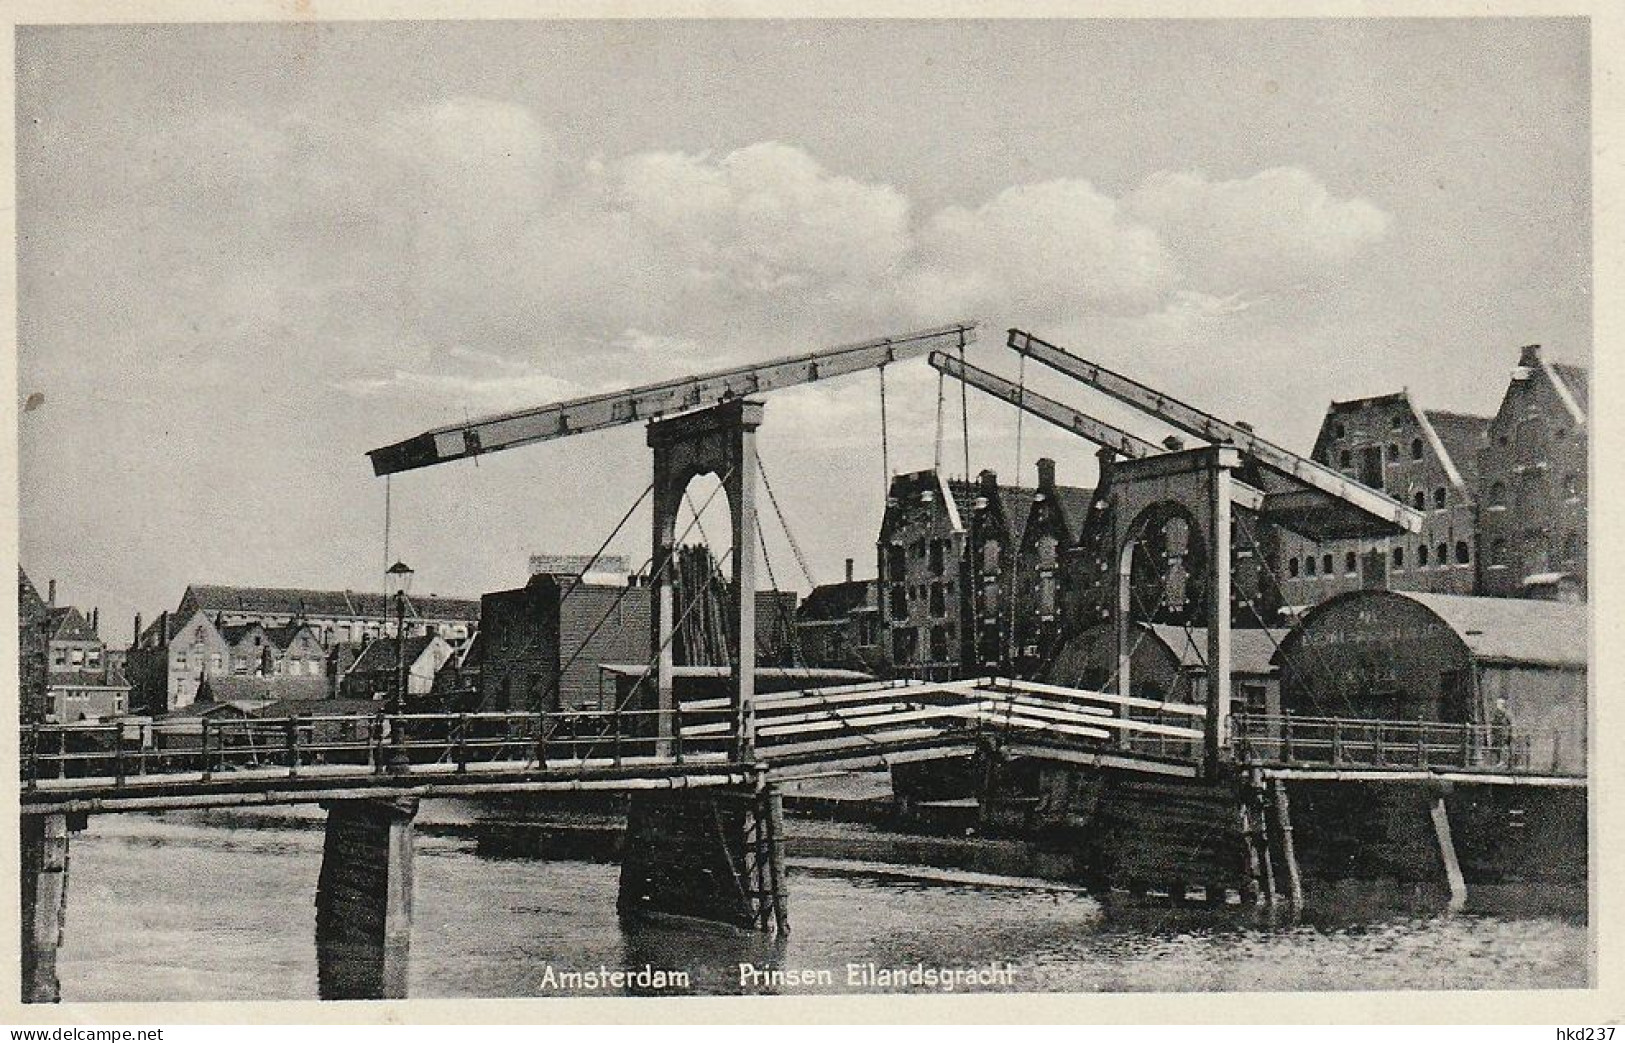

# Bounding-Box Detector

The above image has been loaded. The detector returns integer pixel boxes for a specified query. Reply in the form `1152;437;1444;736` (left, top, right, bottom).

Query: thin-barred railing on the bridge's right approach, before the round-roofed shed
1230;713;1584;775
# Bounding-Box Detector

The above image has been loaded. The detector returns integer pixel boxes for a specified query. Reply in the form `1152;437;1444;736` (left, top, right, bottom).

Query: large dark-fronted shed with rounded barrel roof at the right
1274;590;1589;760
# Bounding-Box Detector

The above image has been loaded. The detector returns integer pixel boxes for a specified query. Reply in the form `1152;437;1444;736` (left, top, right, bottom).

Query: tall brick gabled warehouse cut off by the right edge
1479;344;1591;598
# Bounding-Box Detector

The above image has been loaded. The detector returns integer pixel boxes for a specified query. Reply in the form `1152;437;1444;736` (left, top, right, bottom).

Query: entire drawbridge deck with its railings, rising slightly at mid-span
21;677;1584;814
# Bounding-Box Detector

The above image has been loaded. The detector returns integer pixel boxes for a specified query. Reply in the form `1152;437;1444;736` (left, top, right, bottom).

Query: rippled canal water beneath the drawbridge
59;799;1589;1001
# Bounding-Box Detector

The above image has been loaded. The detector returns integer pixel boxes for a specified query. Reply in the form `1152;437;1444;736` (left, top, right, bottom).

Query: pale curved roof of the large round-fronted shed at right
1388;591;1591;669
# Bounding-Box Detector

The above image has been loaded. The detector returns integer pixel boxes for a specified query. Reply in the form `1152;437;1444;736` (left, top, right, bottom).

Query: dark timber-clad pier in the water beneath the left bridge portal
616;781;790;934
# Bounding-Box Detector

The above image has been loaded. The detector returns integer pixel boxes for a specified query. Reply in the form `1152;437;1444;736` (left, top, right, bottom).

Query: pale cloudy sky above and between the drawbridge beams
16;18;1593;640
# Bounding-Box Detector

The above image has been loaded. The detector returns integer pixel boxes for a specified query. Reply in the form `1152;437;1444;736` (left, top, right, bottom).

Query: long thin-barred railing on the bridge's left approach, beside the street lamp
20;710;730;788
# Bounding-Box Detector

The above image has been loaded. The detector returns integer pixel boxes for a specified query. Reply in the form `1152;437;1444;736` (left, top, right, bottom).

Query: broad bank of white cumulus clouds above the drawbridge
79;96;1391;411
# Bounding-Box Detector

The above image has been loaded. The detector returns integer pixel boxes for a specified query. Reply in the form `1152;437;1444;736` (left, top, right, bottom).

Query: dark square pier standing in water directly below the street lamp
315;798;418;999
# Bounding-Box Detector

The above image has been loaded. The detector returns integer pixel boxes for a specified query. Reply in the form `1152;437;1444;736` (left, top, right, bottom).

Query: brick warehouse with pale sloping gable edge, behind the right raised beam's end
1272;392;1490;608
